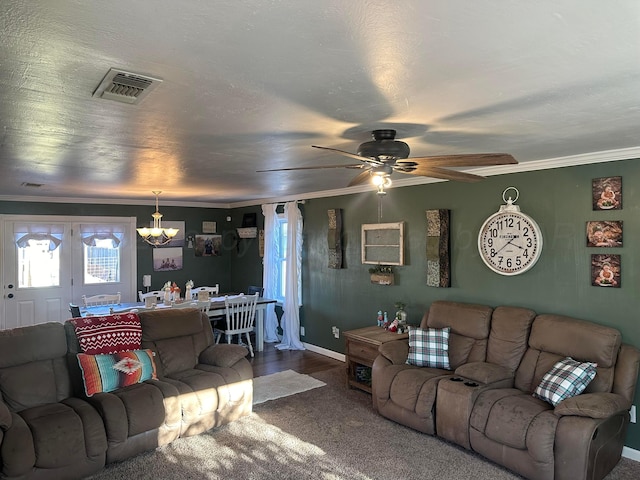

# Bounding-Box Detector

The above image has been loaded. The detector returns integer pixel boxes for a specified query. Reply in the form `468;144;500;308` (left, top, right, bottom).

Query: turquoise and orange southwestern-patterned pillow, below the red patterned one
78;350;157;397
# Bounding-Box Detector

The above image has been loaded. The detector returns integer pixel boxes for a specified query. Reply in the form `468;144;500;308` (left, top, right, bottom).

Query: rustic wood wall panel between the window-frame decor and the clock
427;210;451;288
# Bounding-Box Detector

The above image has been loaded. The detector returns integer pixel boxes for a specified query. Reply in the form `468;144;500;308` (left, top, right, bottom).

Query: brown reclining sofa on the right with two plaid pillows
372;301;640;480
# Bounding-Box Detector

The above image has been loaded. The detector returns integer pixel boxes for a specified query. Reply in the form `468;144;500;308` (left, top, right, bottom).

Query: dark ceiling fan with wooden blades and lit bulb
258;129;518;187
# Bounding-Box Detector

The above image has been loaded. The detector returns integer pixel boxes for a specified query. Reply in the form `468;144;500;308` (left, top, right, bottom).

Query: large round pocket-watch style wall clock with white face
478;187;542;275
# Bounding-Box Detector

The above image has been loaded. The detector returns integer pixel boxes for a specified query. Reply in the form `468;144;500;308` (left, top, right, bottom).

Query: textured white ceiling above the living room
0;0;640;204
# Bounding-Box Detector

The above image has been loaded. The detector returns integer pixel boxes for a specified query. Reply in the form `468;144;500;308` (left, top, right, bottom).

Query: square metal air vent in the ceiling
93;68;162;104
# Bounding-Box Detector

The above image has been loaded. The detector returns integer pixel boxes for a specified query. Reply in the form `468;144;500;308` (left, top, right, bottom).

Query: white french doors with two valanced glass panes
0;215;136;329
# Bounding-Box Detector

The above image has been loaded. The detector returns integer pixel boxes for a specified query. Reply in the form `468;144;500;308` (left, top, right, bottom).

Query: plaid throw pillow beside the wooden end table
407;326;451;370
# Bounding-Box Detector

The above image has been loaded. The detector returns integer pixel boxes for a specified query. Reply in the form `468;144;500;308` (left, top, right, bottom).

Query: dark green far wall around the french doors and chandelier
0;202;235;291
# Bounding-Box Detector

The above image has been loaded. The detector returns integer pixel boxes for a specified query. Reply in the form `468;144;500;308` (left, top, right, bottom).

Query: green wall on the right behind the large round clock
302;160;640;449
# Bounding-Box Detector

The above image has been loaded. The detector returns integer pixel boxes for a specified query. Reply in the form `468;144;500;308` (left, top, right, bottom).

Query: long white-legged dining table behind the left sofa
80;294;276;352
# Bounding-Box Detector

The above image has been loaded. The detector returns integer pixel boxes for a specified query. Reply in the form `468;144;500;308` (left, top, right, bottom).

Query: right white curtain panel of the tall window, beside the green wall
276;202;305;350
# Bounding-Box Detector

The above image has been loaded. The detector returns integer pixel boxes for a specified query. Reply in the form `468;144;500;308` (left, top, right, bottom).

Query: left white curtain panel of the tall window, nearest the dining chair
262;204;278;343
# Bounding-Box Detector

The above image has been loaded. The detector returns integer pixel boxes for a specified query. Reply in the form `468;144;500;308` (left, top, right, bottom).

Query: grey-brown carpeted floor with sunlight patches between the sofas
86;368;640;480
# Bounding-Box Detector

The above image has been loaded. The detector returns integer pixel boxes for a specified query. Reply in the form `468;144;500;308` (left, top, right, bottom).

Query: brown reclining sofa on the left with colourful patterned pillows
0;309;253;480
